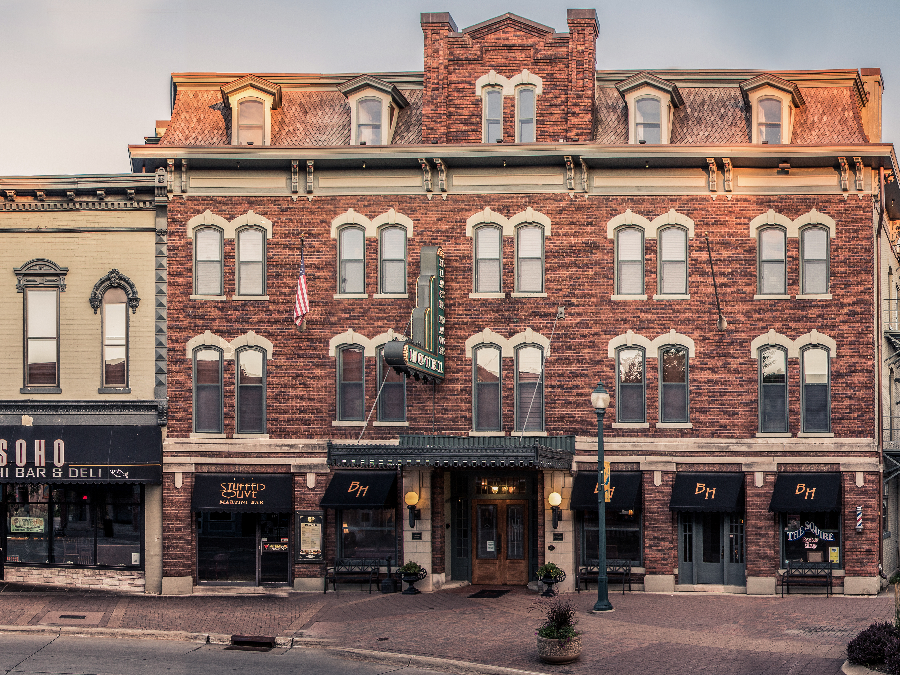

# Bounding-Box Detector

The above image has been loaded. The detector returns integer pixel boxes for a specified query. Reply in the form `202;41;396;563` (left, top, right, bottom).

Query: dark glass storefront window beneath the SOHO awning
6;485;144;568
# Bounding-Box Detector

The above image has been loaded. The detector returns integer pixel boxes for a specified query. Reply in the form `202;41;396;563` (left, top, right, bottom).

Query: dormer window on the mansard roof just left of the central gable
338;75;409;145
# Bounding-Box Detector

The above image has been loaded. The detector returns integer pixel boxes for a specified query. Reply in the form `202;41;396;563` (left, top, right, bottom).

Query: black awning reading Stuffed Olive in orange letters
191;473;293;513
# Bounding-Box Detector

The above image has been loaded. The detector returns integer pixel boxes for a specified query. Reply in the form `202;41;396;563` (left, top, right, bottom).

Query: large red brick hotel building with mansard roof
130;10;900;594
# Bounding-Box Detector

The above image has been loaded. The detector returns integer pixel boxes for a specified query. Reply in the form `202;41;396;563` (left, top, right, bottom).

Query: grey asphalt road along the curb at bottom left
0;634;468;675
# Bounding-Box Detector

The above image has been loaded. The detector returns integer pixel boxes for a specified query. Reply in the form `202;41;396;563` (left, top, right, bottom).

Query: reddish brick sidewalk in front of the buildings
0;585;893;675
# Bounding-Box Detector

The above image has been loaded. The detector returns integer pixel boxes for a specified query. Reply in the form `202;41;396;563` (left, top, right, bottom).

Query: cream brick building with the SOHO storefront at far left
0;175;166;593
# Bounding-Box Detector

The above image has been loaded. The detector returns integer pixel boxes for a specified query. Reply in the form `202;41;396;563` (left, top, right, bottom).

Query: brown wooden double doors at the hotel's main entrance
472;499;528;584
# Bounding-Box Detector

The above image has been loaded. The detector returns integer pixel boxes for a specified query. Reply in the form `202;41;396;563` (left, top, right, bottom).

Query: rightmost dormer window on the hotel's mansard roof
741;73;805;145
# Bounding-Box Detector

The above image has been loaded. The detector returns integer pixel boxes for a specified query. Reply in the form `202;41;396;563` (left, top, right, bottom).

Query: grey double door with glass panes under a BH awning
678;513;746;586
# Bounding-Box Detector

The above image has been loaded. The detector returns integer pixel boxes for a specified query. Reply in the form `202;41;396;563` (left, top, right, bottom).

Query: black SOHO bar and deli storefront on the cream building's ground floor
0;412;164;592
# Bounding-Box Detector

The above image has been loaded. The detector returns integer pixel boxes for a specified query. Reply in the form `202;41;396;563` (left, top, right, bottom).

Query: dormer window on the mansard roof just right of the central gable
616;72;684;145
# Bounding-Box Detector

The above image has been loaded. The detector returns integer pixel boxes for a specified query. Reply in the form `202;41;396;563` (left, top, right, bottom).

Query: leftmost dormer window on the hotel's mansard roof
222;75;281;145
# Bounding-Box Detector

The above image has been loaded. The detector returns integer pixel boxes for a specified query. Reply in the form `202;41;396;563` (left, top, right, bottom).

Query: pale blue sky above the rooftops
0;0;900;175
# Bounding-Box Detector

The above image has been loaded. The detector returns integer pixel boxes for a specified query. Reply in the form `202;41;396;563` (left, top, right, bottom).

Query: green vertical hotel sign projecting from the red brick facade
384;246;447;382
